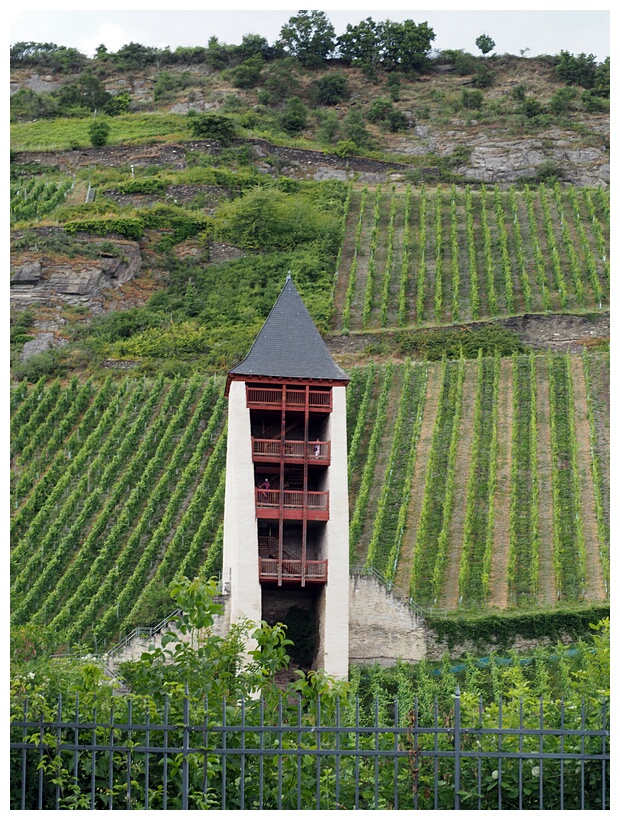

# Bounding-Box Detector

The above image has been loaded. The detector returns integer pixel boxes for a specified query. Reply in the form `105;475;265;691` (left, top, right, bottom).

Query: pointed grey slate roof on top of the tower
228;273;349;382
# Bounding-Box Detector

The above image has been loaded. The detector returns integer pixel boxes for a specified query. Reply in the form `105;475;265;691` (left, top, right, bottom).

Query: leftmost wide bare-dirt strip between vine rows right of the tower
394;365;441;592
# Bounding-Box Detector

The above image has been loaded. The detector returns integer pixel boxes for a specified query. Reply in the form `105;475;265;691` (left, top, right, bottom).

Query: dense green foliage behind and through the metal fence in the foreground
11;577;610;809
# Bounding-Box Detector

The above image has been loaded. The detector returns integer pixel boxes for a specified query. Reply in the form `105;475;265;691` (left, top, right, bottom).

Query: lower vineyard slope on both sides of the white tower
11;351;609;646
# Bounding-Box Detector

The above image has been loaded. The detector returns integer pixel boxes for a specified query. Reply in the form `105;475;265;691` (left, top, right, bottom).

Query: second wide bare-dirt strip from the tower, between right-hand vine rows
438;362;477;610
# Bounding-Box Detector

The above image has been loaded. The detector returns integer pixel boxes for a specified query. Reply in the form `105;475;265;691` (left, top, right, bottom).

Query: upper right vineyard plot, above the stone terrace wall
334;183;610;332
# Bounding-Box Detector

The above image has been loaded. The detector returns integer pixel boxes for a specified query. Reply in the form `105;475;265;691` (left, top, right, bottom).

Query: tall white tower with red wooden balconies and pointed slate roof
222;274;349;678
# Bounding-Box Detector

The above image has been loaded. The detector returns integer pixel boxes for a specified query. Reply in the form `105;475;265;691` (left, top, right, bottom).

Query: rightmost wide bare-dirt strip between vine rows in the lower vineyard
571;356;606;601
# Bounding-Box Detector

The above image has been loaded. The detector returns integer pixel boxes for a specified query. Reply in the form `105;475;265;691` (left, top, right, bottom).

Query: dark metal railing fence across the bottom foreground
11;691;609;810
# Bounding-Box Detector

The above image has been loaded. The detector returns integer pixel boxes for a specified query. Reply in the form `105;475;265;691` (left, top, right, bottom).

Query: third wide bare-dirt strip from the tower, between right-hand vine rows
489;359;513;609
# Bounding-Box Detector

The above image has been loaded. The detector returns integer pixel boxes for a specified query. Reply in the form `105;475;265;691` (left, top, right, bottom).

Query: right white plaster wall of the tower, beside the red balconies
317;386;349;678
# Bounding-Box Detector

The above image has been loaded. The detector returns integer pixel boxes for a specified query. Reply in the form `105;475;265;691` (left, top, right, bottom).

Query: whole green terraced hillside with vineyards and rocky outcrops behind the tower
10;22;611;647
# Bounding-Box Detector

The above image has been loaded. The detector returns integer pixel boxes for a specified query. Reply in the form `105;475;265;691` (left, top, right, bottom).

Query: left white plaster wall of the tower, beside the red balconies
222;381;261;625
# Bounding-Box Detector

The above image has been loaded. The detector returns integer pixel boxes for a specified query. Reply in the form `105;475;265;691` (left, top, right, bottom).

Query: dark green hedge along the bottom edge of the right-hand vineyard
426;604;609;648
